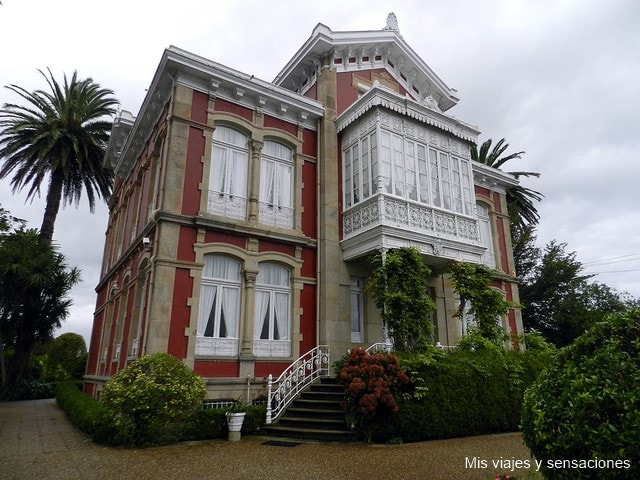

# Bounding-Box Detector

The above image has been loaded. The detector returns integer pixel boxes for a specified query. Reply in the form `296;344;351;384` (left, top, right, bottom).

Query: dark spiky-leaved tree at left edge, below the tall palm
0;230;80;383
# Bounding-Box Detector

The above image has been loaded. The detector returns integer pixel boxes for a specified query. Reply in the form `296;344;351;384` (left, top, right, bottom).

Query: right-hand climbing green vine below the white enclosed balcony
449;262;514;343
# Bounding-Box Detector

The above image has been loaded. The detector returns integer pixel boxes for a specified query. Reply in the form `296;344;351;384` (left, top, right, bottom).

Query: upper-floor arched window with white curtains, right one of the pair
260;140;293;228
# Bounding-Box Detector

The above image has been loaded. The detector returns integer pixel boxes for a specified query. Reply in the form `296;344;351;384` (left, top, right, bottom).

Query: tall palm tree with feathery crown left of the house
0;70;118;242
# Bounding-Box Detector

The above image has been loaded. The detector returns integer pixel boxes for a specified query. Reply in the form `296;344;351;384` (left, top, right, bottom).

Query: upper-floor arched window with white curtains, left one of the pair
207;126;249;218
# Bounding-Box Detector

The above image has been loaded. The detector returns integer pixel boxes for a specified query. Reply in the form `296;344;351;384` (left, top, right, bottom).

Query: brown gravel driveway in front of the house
0;400;536;480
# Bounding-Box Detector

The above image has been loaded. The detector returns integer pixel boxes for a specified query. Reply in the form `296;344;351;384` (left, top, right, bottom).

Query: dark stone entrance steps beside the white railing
263;377;359;442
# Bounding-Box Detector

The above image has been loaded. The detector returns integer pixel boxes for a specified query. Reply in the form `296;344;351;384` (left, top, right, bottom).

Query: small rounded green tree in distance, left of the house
46;332;87;381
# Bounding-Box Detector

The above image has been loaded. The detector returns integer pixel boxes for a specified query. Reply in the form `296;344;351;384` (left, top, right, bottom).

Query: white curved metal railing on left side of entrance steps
266;345;330;425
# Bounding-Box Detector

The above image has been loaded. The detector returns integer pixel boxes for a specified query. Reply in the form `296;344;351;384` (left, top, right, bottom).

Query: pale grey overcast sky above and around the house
0;0;640;342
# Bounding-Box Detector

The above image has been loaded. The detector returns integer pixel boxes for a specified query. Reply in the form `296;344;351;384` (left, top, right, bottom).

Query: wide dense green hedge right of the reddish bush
372;341;550;443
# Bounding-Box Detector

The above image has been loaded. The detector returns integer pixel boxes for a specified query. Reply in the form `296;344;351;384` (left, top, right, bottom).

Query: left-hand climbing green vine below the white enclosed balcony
367;247;436;351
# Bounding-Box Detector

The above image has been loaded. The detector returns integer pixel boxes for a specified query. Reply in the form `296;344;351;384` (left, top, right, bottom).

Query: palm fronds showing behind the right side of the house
471;138;544;229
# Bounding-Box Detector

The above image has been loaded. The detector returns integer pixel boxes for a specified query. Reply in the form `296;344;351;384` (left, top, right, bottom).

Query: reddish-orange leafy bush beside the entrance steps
339;348;409;433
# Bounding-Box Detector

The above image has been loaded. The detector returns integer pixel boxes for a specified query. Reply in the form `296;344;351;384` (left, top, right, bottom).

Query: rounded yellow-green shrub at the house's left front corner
100;353;206;445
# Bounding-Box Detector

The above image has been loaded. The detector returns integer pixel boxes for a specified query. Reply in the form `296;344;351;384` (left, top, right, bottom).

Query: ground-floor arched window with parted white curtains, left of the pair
196;254;240;355
